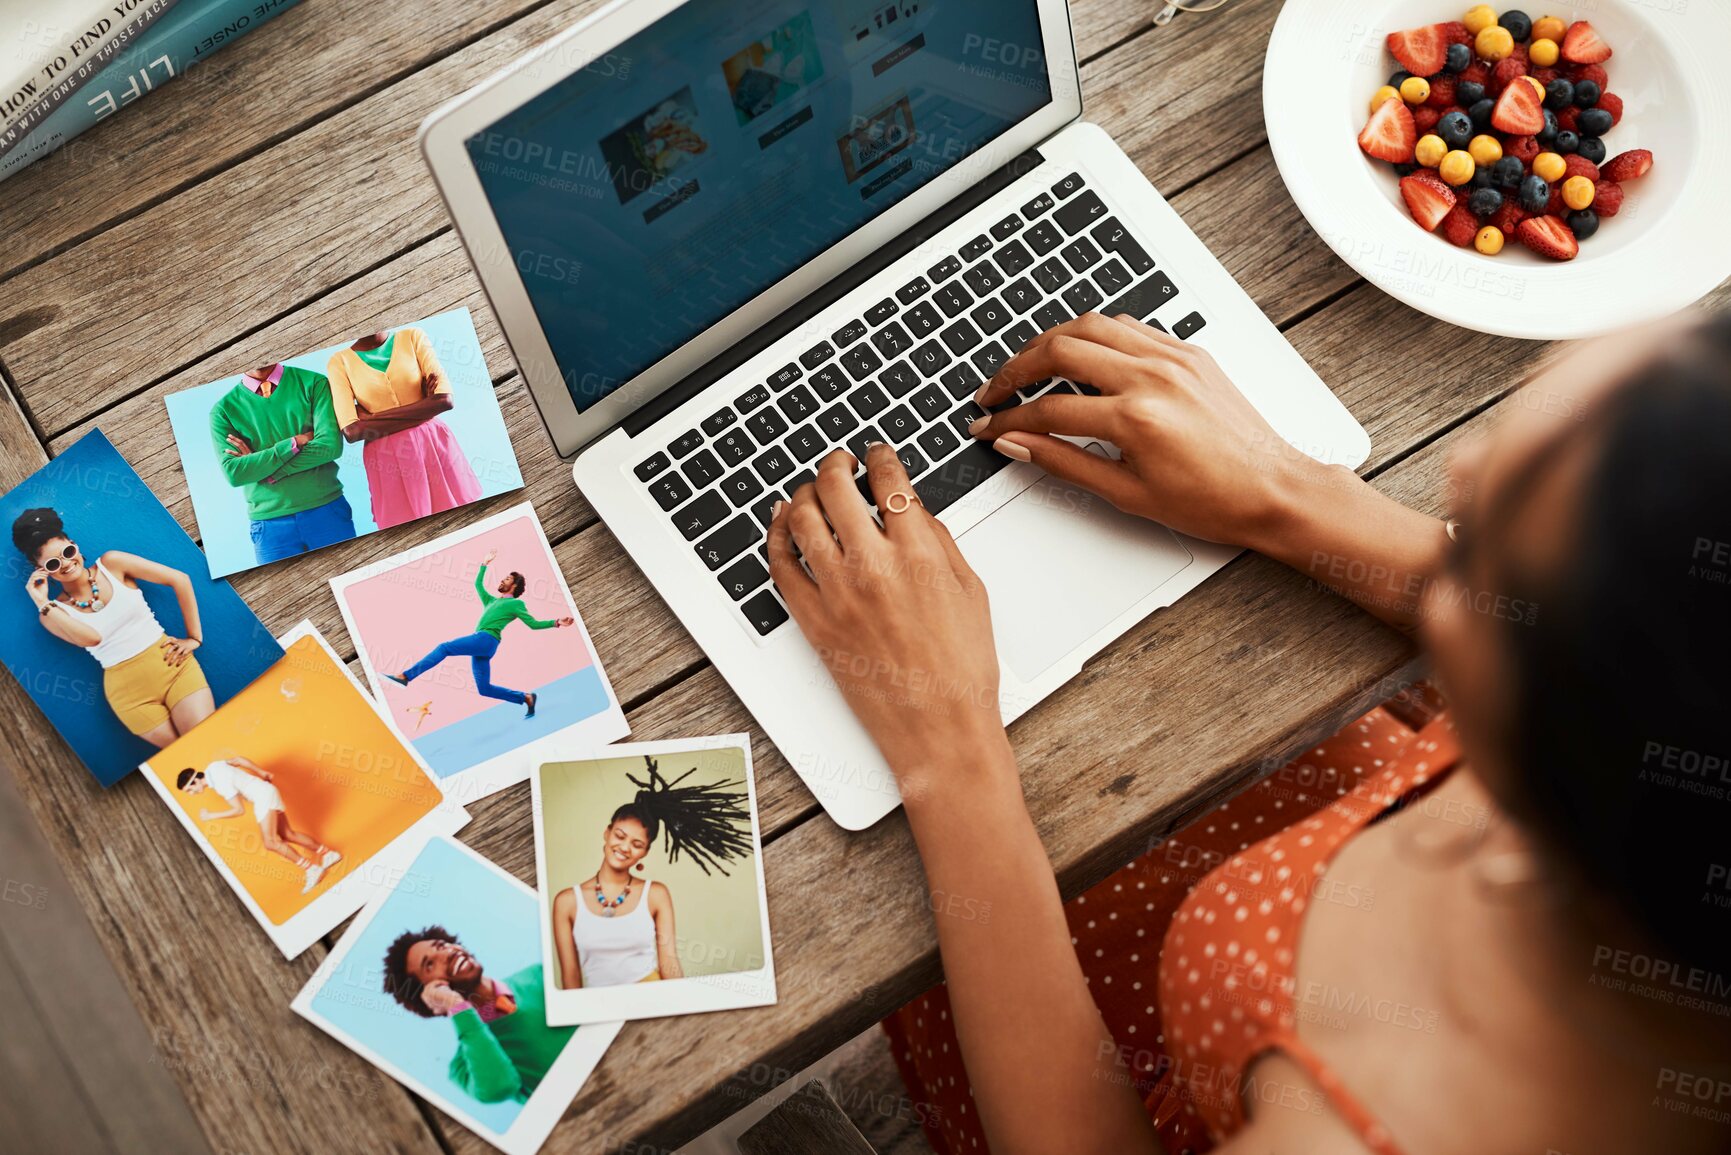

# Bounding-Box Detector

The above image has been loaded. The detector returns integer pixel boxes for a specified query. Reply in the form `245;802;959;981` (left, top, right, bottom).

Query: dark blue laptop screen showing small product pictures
467;0;1051;412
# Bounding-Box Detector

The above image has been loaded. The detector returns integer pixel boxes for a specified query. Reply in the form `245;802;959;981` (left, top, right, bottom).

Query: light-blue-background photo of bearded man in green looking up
294;838;620;1155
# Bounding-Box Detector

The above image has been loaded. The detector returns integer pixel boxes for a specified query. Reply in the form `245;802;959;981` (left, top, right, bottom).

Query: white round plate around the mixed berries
1262;0;1731;339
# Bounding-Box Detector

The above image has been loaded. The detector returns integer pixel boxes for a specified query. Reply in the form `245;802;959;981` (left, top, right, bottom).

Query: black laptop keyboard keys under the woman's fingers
634;173;1207;636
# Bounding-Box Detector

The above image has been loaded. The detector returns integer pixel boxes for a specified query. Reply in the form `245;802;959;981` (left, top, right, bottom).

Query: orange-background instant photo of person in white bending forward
144;622;469;958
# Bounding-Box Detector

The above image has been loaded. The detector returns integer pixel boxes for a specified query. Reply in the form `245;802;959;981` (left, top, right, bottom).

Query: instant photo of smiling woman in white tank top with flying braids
533;734;775;1023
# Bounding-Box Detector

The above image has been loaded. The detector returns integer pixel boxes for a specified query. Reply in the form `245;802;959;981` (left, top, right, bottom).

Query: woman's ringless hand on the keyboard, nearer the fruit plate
971;313;1324;549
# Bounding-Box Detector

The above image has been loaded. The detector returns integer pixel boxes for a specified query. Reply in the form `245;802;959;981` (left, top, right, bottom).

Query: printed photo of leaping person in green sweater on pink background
331;502;630;802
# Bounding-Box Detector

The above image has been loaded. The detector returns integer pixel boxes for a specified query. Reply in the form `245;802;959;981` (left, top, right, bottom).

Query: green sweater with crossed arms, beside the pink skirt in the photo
211;365;343;521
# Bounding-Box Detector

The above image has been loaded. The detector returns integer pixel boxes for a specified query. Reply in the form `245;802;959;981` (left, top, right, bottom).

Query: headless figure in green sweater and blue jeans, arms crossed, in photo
211;364;355;565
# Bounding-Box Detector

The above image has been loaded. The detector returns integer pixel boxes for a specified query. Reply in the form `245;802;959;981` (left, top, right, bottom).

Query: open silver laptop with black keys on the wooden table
421;0;1369;829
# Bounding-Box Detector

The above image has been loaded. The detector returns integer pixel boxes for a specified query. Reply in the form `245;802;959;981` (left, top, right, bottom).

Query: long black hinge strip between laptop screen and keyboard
620;149;1046;436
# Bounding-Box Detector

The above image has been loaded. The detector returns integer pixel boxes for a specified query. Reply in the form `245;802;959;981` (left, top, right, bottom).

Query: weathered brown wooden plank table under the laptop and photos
0;0;1731;1155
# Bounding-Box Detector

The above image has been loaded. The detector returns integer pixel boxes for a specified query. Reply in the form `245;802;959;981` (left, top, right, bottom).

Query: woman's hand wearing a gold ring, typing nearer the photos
769;443;1007;797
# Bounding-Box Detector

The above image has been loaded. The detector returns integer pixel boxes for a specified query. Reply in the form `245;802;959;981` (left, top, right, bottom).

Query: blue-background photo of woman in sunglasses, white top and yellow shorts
0;431;282;786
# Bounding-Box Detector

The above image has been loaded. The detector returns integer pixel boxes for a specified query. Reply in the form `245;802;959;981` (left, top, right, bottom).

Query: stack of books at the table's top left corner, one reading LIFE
0;0;299;180
